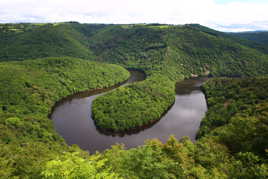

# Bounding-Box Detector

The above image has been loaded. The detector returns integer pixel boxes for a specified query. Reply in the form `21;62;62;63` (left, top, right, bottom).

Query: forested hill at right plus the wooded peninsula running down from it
90;25;268;131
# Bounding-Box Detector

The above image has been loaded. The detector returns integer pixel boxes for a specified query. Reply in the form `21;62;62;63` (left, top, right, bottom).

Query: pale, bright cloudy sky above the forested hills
0;0;268;31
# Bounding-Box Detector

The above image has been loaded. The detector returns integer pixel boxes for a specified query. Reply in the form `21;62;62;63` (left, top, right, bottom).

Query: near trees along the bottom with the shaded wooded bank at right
42;78;268;179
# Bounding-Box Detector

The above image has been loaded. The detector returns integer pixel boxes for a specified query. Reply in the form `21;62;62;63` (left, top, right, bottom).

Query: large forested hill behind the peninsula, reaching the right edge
87;22;268;79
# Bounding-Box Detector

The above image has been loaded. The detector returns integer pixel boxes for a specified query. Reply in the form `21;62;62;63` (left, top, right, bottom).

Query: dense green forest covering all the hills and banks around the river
0;22;268;179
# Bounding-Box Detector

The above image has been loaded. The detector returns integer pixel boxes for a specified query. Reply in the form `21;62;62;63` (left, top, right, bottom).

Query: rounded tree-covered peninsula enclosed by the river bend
92;75;175;132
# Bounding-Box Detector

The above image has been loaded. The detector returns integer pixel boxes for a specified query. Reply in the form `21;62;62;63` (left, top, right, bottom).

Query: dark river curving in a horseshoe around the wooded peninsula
51;71;207;152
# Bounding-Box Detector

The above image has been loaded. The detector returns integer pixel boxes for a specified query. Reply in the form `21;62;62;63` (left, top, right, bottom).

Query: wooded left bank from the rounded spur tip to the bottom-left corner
0;57;129;178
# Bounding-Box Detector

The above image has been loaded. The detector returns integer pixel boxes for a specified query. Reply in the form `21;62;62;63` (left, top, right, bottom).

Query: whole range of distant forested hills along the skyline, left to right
0;22;268;79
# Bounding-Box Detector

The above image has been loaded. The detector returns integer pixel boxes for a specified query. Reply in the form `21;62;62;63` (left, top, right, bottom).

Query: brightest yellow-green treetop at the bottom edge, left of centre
41;152;119;179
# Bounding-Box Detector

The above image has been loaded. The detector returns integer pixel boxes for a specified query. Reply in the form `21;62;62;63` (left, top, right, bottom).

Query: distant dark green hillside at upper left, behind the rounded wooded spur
0;23;97;60
